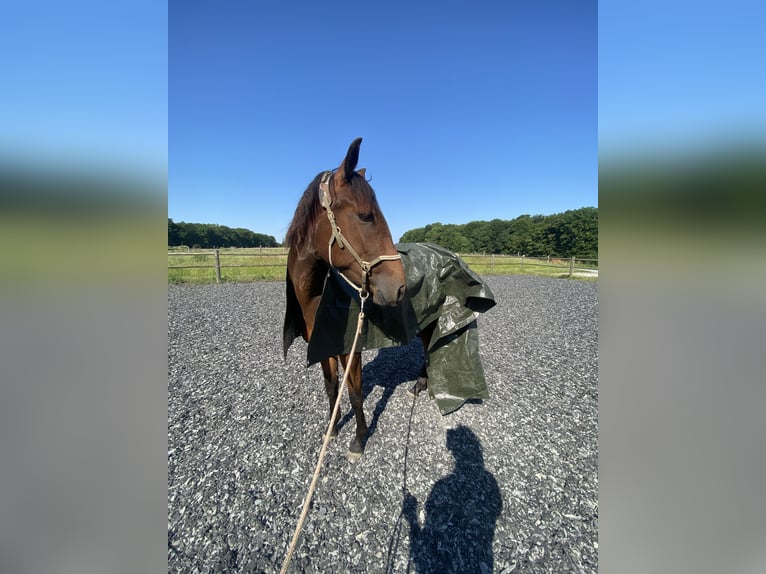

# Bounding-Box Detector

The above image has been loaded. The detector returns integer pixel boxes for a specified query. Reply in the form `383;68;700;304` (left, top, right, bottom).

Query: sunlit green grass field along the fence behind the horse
168;247;597;283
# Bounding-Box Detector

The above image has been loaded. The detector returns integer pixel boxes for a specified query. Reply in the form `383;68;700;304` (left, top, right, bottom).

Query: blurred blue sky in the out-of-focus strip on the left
0;0;168;180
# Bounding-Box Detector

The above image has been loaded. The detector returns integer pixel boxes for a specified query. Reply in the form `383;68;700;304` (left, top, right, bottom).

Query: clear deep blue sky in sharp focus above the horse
168;0;598;241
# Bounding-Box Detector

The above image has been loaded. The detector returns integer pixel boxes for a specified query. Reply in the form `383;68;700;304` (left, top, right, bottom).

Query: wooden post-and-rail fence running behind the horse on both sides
168;248;598;283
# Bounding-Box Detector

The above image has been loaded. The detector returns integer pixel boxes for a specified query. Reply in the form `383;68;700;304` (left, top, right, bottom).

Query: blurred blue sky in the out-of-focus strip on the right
598;0;766;161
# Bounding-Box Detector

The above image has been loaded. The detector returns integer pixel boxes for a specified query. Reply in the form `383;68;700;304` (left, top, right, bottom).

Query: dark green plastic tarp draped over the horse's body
284;243;495;415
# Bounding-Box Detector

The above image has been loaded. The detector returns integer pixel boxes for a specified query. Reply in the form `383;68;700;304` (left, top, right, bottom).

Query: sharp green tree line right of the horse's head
401;207;598;259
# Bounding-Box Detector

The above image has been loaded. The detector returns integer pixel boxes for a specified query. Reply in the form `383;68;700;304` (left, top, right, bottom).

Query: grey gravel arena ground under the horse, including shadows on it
168;276;598;573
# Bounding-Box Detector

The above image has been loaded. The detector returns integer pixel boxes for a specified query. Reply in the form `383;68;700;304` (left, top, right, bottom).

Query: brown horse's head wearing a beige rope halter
316;138;406;306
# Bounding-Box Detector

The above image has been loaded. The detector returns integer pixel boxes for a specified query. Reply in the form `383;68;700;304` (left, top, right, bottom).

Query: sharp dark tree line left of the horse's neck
168;218;279;249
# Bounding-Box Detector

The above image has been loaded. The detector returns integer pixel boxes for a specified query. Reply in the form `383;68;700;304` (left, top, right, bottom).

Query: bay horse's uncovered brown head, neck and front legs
285;138;406;461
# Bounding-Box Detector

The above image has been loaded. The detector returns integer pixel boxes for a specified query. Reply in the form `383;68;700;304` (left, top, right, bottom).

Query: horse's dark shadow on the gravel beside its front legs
338;338;425;440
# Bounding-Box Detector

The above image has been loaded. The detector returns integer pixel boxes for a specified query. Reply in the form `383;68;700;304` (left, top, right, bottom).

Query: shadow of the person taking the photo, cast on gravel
402;426;503;574
